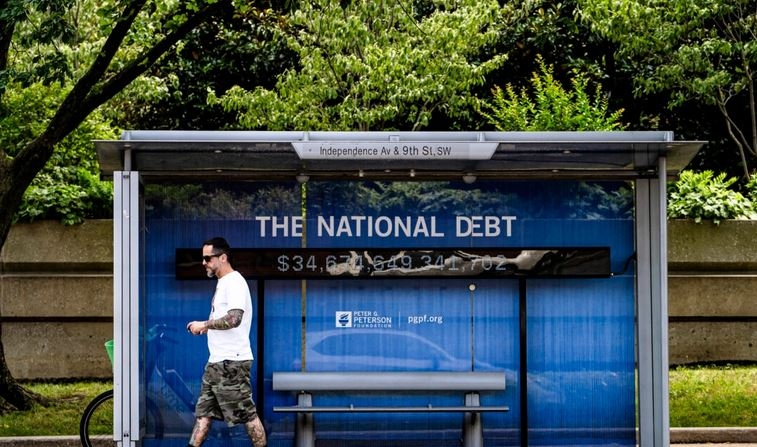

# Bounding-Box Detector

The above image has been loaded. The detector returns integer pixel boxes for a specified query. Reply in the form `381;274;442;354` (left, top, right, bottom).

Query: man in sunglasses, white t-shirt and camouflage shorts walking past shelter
187;237;267;447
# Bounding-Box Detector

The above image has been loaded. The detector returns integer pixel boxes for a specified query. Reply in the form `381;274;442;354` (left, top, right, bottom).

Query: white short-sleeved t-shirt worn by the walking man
208;270;252;363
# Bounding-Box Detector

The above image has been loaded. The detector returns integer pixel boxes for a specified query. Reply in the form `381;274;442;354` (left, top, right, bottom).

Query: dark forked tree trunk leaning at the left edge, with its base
0;0;227;414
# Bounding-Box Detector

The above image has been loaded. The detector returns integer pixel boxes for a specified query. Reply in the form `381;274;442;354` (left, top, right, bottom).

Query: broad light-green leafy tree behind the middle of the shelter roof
210;0;528;131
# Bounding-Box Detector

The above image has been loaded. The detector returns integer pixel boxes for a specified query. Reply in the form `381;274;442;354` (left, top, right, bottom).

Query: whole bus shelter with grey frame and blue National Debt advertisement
96;131;704;447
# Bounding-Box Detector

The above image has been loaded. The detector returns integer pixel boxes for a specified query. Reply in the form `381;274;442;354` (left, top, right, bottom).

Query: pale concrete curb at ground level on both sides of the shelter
0;427;757;447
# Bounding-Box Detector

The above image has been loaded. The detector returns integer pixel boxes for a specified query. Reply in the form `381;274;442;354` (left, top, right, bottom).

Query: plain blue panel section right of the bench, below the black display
527;276;636;446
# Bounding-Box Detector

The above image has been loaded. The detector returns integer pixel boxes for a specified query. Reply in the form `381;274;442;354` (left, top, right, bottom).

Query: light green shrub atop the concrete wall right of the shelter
668;170;755;224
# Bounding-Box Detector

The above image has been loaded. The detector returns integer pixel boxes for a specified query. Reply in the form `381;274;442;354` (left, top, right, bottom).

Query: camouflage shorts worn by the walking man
195;360;256;425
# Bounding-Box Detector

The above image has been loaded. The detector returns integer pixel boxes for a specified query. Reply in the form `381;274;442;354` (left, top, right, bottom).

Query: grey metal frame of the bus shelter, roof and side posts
95;131;705;447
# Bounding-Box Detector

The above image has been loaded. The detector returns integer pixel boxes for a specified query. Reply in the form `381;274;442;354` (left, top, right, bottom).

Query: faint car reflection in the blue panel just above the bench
292;328;496;371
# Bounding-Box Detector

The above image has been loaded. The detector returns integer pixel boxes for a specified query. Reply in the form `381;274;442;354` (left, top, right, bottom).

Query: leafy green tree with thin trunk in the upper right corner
579;0;757;177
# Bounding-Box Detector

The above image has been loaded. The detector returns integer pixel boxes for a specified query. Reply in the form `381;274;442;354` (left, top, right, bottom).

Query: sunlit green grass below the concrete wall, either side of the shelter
0;365;757;437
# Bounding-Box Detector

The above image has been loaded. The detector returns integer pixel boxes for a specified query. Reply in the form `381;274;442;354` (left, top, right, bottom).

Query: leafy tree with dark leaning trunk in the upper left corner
0;0;252;413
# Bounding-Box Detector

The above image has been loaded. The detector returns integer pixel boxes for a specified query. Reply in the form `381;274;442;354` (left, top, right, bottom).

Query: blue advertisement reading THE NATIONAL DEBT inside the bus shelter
140;180;636;447
